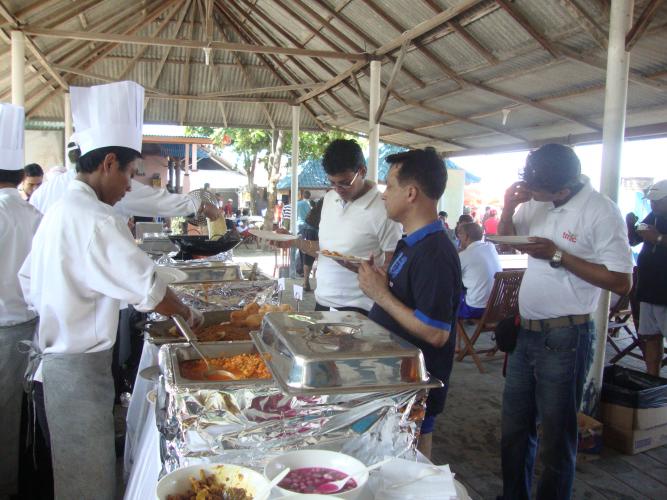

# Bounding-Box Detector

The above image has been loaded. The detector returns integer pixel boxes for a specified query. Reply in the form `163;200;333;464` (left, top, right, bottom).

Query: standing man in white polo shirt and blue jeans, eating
498;144;632;500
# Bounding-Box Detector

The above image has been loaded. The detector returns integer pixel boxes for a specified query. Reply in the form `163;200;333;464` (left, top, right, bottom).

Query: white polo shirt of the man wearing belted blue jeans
513;182;633;319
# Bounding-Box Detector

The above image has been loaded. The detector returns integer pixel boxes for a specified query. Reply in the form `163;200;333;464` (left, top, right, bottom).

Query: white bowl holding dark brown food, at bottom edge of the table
156;464;270;500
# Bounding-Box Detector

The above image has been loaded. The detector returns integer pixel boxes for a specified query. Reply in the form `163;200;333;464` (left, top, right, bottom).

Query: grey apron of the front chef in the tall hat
42;349;116;500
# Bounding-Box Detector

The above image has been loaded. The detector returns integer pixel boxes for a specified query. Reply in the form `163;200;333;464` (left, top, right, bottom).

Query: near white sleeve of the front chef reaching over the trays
84;217;167;312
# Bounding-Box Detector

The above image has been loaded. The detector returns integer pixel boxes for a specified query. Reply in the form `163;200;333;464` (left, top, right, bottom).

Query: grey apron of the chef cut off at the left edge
0;318;37;498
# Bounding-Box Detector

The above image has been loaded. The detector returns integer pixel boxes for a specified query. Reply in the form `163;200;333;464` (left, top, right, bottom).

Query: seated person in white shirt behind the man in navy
458;222;503;319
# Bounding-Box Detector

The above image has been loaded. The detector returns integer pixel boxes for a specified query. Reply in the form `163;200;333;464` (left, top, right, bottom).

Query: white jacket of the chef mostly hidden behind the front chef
30;169;199;218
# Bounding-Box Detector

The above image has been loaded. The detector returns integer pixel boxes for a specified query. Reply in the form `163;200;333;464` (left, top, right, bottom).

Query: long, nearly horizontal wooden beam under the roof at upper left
23;27;368;61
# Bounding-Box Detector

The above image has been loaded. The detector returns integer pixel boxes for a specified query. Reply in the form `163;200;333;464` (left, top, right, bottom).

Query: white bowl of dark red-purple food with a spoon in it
264;450;368;500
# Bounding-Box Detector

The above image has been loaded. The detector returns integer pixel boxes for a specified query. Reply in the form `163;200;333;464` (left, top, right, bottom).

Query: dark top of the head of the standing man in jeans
523;144;581;193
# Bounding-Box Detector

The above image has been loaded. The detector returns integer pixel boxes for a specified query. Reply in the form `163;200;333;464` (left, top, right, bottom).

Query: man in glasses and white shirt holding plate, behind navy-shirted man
295;139;401;315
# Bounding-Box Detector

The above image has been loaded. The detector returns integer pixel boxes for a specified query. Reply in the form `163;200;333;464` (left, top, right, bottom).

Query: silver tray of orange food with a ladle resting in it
167;341;274;389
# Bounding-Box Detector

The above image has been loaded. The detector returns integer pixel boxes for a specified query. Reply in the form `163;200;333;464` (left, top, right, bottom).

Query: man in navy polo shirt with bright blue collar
359;149;462;457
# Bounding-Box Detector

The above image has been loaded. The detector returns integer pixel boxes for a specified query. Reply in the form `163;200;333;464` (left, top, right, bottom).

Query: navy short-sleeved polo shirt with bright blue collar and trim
368;221;462;415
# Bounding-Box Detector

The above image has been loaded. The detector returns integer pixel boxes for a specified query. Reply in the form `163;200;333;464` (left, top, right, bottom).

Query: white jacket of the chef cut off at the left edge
0;188;42;326
